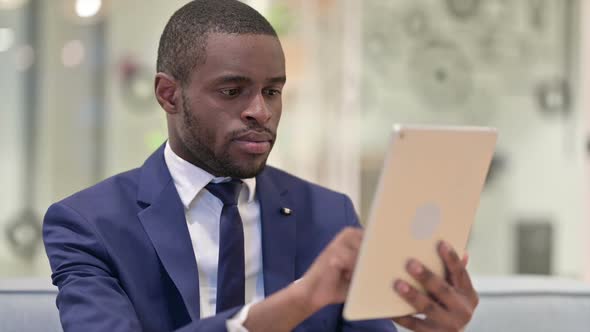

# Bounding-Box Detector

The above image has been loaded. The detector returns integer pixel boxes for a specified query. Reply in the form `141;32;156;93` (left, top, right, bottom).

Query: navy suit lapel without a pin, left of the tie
138;147;200;320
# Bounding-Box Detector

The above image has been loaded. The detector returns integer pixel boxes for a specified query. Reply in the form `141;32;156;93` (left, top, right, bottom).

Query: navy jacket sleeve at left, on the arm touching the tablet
43;203;240;332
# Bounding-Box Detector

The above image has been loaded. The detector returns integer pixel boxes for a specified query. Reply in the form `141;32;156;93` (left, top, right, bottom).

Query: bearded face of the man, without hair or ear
176;33;286;178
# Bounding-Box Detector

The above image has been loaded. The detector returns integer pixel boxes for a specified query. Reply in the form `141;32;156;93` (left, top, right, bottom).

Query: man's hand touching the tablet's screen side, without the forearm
299;227;363;310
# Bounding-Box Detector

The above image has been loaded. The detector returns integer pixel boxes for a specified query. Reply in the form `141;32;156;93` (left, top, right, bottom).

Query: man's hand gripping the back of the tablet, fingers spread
394;242;479;332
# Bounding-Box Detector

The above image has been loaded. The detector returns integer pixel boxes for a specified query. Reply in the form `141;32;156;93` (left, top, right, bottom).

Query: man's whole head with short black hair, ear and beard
155;0;286;178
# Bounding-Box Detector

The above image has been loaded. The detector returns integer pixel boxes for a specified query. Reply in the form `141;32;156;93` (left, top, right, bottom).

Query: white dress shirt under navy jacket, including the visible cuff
164;143;264;332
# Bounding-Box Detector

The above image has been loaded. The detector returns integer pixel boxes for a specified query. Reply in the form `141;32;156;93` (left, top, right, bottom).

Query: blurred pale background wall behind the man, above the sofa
0;0;590;280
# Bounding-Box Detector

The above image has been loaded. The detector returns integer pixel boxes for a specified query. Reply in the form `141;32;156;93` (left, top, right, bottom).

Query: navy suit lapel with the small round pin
256;170;297;297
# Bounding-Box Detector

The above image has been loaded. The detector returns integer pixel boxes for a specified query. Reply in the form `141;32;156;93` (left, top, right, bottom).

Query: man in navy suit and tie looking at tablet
44;0;477;332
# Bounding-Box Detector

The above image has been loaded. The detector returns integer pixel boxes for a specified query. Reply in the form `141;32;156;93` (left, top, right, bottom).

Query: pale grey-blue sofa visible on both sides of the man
0;276;590;332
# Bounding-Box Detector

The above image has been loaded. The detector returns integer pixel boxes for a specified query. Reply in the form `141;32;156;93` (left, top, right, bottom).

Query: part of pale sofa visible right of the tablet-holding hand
399;276;590;332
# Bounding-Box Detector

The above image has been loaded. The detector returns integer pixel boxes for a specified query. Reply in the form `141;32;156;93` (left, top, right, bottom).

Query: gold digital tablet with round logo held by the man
343;125;497;320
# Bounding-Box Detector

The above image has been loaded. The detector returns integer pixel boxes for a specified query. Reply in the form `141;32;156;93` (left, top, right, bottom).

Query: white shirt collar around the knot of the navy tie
164;142;256;209
